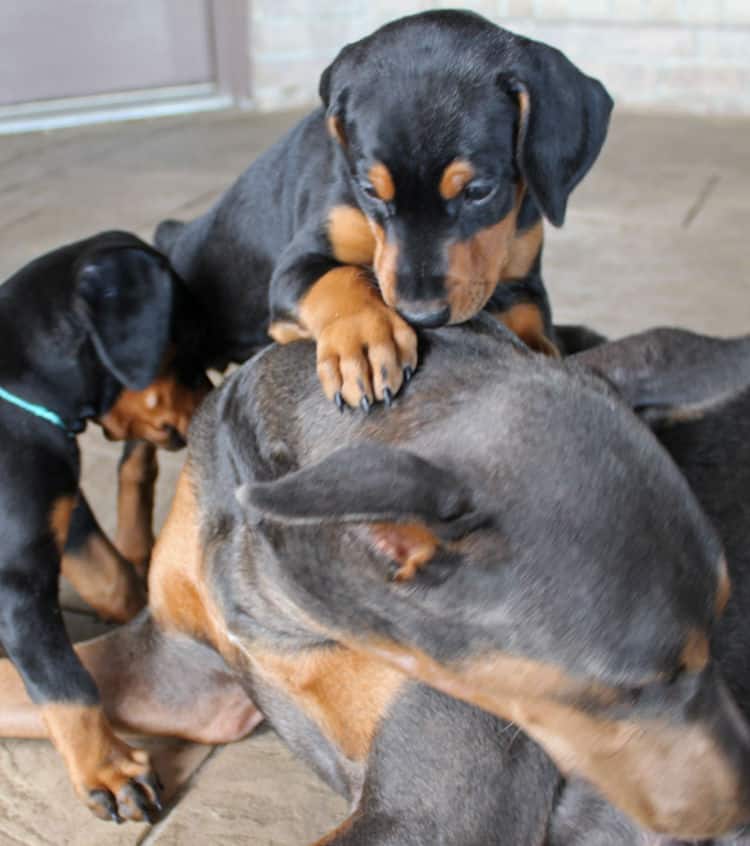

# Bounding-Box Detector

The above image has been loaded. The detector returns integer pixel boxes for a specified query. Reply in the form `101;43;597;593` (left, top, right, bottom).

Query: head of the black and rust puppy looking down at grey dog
320;11;612;326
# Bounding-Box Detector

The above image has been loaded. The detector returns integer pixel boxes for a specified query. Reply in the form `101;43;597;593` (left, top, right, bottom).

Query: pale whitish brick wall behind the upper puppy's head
248;0;750;114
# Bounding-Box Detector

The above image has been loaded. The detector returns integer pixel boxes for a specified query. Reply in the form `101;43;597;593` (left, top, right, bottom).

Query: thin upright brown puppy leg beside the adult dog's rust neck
115;441;159;577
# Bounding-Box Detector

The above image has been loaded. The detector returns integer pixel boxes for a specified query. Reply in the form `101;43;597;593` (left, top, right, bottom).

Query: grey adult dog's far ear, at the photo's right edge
569;329;750;428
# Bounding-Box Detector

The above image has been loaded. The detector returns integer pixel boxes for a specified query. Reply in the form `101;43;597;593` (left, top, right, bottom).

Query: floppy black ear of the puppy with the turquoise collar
76;247;174;390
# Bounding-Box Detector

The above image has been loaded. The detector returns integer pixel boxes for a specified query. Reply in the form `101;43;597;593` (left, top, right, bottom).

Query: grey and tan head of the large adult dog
235;322;750;837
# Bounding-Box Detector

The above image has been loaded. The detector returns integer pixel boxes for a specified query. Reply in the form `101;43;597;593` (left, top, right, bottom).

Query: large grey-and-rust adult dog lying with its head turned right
0;319;750;846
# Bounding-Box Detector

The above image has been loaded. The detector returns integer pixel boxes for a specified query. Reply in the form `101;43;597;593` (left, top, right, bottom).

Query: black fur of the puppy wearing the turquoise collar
0;232;205;716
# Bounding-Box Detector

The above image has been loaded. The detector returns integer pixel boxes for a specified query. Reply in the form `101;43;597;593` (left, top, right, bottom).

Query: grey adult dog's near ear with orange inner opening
237;443;488;579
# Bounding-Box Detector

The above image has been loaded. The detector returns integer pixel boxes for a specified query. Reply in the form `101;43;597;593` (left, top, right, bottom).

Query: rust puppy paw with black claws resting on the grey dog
318;298;417;411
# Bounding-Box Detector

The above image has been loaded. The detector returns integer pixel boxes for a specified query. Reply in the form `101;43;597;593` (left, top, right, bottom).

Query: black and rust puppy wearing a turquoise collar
0;232;208;817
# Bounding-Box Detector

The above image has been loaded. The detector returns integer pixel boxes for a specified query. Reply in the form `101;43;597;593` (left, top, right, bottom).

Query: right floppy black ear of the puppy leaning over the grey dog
499;39;613;226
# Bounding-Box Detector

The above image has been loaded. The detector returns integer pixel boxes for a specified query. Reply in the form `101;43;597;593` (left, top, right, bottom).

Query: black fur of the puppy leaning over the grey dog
156;11;612;367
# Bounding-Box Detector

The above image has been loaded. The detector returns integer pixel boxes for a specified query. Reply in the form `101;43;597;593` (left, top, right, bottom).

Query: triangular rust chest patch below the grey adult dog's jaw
247;646;406;761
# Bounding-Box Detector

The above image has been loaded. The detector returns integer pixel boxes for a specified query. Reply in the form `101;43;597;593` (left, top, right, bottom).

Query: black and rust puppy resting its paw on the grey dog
156;11;612;409
